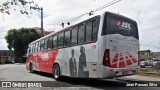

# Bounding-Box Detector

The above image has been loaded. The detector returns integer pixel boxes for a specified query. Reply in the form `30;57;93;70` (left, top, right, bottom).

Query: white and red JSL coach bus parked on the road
26;12;139;80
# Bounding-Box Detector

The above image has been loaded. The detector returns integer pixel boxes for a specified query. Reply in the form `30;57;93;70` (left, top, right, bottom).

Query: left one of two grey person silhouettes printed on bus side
69;49;77;77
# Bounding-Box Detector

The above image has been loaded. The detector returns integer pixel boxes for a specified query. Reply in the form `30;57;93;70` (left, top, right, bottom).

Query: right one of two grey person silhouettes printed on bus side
78;46;89;77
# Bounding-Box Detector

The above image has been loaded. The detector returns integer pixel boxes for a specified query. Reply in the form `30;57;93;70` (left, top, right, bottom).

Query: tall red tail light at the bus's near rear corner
103;49;111;67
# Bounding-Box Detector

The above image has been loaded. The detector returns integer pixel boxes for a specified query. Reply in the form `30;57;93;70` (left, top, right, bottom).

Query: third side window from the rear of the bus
78;24;85;44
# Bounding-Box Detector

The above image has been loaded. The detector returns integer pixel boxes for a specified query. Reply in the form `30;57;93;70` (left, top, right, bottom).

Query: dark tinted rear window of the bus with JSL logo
109;18;138;39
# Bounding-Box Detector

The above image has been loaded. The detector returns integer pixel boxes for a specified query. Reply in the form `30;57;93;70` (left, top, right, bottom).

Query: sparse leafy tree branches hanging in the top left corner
0;0;38;15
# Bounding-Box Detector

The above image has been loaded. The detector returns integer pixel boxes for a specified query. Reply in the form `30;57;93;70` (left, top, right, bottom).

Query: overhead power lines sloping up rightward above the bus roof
46;0;122;25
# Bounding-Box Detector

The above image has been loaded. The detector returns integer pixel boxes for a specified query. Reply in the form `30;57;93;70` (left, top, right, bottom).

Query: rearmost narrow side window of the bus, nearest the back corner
92;20;98;41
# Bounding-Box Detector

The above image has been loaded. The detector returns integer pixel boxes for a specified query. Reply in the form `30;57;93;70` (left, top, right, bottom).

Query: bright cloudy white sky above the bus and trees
0;0;160;52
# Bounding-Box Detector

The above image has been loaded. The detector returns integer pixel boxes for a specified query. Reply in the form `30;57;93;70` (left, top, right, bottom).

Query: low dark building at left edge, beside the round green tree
0;50;13;64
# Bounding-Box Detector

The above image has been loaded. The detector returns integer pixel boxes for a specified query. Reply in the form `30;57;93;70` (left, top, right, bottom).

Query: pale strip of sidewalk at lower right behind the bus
117;75;160;82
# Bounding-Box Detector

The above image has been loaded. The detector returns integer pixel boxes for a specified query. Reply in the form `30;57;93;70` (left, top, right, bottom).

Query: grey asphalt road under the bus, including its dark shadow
0;64;160;90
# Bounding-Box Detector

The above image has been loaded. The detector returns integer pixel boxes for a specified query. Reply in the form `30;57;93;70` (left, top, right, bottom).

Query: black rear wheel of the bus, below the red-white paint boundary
53;64;61;81
